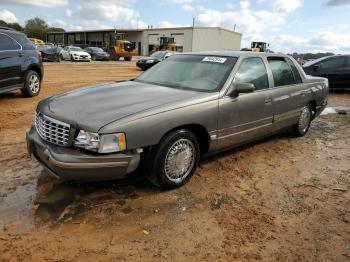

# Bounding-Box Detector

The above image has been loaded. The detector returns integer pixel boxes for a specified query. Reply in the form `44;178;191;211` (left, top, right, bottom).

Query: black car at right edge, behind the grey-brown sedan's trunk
303;55;350;90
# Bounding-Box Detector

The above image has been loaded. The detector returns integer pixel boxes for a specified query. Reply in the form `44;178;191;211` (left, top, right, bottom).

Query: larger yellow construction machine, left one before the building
106;33;136;61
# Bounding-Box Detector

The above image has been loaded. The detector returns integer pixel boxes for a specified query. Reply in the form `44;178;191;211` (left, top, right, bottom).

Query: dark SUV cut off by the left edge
0;27;44;97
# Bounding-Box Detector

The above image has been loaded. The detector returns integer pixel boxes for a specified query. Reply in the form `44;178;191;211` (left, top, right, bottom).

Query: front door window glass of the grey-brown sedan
235;57;269;90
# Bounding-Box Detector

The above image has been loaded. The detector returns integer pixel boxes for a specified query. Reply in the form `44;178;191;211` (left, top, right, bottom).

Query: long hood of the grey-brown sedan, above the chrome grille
37;81;205;132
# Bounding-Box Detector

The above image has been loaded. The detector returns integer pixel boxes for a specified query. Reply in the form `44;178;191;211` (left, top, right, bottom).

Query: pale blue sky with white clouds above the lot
0;0;350;53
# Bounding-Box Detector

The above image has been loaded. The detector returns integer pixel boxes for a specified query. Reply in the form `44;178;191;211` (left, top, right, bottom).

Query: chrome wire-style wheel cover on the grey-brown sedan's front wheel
165;139;197;183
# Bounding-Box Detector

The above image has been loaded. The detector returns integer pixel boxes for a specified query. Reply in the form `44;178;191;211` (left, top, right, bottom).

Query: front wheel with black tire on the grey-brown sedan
148;129;200;189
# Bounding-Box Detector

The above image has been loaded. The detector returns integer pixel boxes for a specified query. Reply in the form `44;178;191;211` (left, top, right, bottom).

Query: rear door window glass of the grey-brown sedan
268;57;296;87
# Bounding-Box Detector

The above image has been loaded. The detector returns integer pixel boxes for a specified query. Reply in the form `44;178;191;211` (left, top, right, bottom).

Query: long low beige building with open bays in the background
46;27;242;56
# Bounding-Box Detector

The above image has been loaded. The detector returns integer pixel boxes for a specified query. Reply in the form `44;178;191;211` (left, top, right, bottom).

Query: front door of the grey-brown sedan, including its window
217;57;273;149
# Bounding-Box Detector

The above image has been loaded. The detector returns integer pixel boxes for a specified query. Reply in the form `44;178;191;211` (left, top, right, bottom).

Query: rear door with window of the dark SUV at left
0;33;22;89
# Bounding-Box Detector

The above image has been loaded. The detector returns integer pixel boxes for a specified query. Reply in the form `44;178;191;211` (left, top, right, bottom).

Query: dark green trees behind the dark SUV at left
0;17;65;41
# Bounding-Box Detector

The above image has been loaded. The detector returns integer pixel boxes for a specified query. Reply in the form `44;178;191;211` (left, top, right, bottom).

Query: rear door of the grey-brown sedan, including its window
267;56;306;129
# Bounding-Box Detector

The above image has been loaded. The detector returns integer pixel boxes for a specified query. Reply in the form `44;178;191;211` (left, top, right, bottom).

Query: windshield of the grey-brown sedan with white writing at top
135;55;237;92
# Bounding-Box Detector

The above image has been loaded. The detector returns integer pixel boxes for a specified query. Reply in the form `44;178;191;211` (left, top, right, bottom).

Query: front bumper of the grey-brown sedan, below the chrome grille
26;126;140;181
